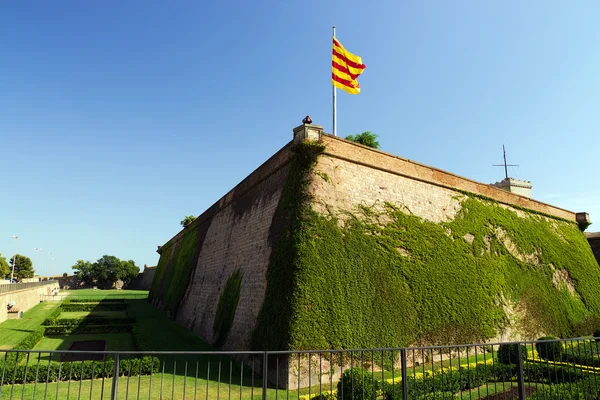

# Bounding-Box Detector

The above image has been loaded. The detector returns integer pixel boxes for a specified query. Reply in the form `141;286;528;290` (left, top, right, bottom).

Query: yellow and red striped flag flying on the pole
331;37;366;94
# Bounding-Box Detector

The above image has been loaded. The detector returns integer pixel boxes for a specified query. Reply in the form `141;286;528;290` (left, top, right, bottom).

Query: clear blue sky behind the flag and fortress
0;0;600;274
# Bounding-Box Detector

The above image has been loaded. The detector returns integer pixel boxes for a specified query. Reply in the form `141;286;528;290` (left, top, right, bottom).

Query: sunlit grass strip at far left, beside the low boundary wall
0;302;60;349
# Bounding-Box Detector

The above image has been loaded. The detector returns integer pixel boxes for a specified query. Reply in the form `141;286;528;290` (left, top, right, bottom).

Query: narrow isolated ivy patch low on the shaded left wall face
213;269;242;347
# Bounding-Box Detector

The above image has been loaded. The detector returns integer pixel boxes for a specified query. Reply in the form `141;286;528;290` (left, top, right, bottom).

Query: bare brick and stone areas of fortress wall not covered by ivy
151;125;592;350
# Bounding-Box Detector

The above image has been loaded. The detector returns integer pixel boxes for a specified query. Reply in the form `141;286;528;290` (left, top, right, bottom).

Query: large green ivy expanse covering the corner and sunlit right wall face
253;144;600;349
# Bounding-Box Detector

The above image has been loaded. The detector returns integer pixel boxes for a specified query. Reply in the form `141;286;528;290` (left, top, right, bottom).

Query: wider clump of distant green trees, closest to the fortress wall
72;255;140;289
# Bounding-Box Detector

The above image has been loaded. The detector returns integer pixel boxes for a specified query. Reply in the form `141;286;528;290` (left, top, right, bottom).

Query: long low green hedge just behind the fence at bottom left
4;353;160;385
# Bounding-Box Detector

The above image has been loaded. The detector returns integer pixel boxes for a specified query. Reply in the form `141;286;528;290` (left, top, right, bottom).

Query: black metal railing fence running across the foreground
0;338;600;400
